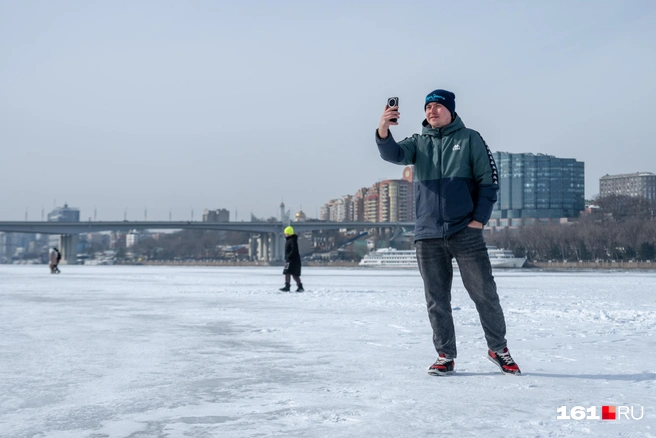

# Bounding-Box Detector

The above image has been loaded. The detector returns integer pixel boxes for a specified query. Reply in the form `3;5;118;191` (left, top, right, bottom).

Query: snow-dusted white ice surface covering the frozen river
0;265;656;438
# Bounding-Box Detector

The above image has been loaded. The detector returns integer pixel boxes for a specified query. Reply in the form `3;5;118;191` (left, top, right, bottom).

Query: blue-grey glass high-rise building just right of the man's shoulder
490;152;585;227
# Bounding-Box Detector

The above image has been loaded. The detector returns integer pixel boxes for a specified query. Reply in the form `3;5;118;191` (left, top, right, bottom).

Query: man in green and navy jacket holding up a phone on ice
376;90;520;375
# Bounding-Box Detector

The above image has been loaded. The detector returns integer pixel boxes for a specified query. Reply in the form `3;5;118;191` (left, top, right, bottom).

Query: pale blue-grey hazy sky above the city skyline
0;0;656;220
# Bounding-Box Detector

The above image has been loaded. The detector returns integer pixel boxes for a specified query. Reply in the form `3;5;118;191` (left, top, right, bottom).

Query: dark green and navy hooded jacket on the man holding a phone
376;114;499;241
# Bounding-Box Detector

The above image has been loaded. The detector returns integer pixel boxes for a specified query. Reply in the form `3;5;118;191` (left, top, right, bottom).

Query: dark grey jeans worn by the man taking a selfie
415;227;506;358
